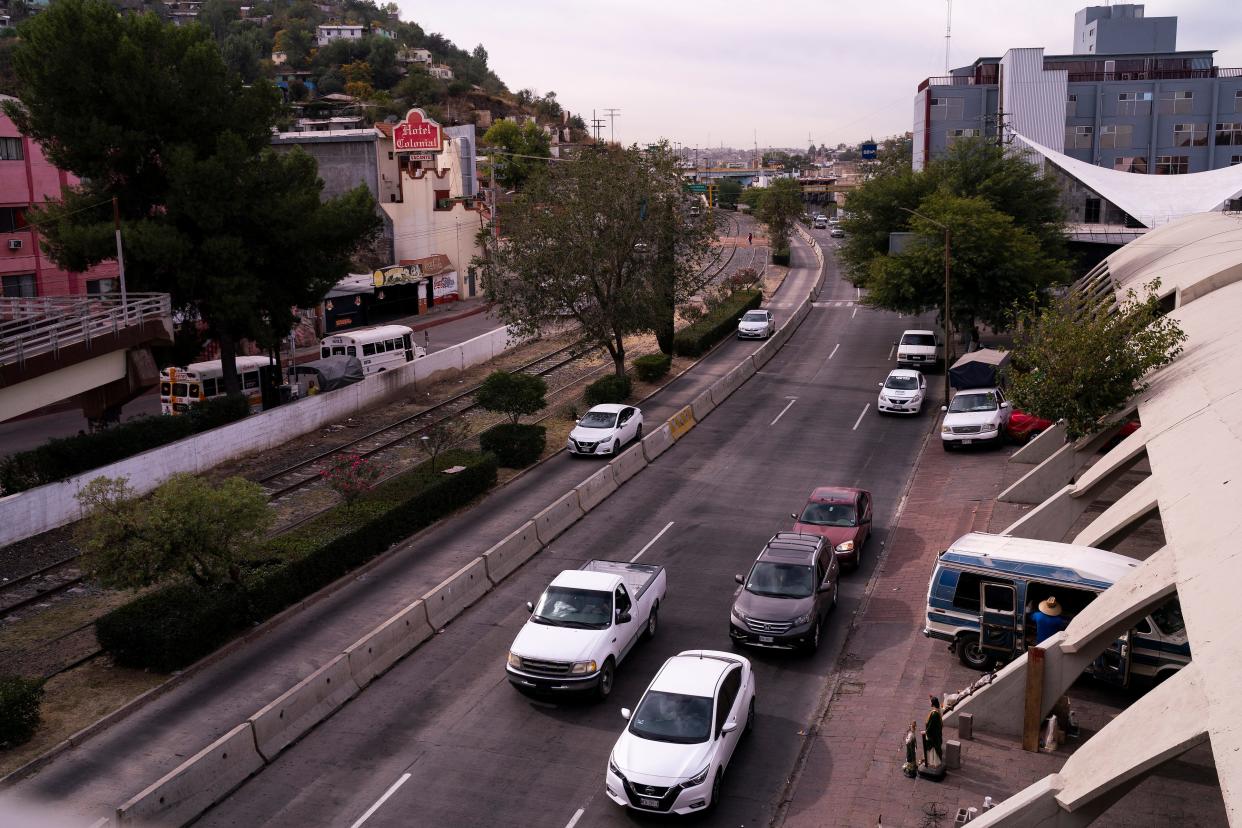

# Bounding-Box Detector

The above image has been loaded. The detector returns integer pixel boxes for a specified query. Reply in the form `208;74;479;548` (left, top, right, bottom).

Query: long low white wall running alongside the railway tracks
0;328;519;546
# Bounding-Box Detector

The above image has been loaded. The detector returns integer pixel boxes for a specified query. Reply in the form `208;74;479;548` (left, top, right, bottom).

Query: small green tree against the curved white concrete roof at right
1010;281;1186;439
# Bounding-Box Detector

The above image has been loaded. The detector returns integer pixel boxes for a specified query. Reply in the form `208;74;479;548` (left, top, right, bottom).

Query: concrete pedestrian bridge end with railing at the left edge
0;293;173;422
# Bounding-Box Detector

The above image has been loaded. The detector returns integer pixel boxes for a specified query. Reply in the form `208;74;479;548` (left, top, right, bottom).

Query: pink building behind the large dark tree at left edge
0;96;120;297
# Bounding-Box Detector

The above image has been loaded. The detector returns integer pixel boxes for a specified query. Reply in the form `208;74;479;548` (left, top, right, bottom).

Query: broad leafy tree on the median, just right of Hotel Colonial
487;144;715;376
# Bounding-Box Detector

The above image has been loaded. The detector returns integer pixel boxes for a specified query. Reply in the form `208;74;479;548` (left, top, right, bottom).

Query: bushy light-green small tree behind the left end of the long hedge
77;474;273;590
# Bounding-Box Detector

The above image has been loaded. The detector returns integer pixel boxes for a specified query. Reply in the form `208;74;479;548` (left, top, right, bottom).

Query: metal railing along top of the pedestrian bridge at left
0;293;173;365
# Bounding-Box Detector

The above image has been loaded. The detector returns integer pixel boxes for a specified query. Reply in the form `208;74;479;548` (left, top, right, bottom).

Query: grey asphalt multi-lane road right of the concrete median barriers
191;235;932;828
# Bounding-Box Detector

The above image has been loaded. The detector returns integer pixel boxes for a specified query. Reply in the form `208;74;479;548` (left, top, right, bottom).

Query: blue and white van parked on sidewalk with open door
923;533;1190;684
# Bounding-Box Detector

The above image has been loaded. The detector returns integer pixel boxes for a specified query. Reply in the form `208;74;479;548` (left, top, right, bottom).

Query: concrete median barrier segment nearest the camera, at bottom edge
117;722;263;826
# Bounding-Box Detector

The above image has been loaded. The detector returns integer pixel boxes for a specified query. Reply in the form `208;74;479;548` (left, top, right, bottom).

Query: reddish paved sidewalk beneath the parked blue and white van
779;431;1226;828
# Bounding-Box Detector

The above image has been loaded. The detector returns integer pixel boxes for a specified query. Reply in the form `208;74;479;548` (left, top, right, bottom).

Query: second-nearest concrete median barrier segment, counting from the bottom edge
250;653;358;762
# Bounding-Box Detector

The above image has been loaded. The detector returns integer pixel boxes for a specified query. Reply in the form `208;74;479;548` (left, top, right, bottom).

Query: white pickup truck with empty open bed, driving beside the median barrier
505;561;668;699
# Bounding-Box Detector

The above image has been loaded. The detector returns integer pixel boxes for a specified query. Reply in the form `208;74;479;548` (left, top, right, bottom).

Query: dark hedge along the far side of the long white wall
0;394;250;494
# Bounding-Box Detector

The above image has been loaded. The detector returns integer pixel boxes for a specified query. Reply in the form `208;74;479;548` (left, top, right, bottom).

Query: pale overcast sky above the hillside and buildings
397;0;1242;146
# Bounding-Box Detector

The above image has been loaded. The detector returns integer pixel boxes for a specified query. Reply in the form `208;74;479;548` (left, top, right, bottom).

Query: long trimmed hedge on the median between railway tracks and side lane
96;451;497;673
